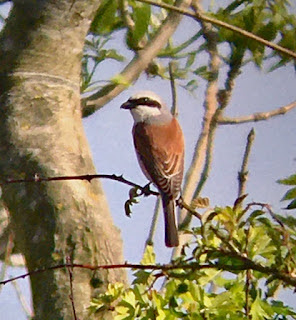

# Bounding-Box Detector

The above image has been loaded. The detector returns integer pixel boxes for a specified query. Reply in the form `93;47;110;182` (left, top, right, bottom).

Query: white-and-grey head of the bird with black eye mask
121;91;172;123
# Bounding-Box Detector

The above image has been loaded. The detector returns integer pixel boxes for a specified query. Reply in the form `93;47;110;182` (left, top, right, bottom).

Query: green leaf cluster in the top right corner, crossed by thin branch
212;0;296;70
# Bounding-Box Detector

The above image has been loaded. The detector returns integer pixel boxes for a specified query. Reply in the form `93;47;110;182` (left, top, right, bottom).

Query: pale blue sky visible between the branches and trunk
0;0;296;320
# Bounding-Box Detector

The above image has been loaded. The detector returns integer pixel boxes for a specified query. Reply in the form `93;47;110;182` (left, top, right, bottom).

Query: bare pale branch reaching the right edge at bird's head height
218;101;296;125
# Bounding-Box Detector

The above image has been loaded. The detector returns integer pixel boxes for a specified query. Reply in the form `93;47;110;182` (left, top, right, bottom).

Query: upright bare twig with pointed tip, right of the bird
237;128;255;198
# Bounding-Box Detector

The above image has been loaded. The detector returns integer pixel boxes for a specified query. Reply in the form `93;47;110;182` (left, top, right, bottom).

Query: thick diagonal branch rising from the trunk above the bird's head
83;0;190;117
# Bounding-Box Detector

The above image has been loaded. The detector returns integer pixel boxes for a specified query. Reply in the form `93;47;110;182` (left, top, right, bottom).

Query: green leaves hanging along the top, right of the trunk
82;0;296;99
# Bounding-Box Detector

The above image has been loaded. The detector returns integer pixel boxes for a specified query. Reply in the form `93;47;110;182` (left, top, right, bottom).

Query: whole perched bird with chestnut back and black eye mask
121;91;184;247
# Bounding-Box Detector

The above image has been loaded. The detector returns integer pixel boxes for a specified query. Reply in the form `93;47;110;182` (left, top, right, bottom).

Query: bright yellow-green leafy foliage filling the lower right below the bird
90;203;296;320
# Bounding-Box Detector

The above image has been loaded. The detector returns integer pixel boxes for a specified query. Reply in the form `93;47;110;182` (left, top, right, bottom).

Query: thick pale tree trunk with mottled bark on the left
0;0;126;320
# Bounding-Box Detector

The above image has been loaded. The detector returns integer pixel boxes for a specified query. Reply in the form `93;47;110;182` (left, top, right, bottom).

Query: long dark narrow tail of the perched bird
161;195;179;247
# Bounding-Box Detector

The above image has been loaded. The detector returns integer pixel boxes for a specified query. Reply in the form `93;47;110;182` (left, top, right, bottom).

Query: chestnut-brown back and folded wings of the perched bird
134;118;184;197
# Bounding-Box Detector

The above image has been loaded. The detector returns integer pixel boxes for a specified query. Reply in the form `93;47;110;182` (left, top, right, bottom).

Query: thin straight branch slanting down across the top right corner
137;0;296;60
